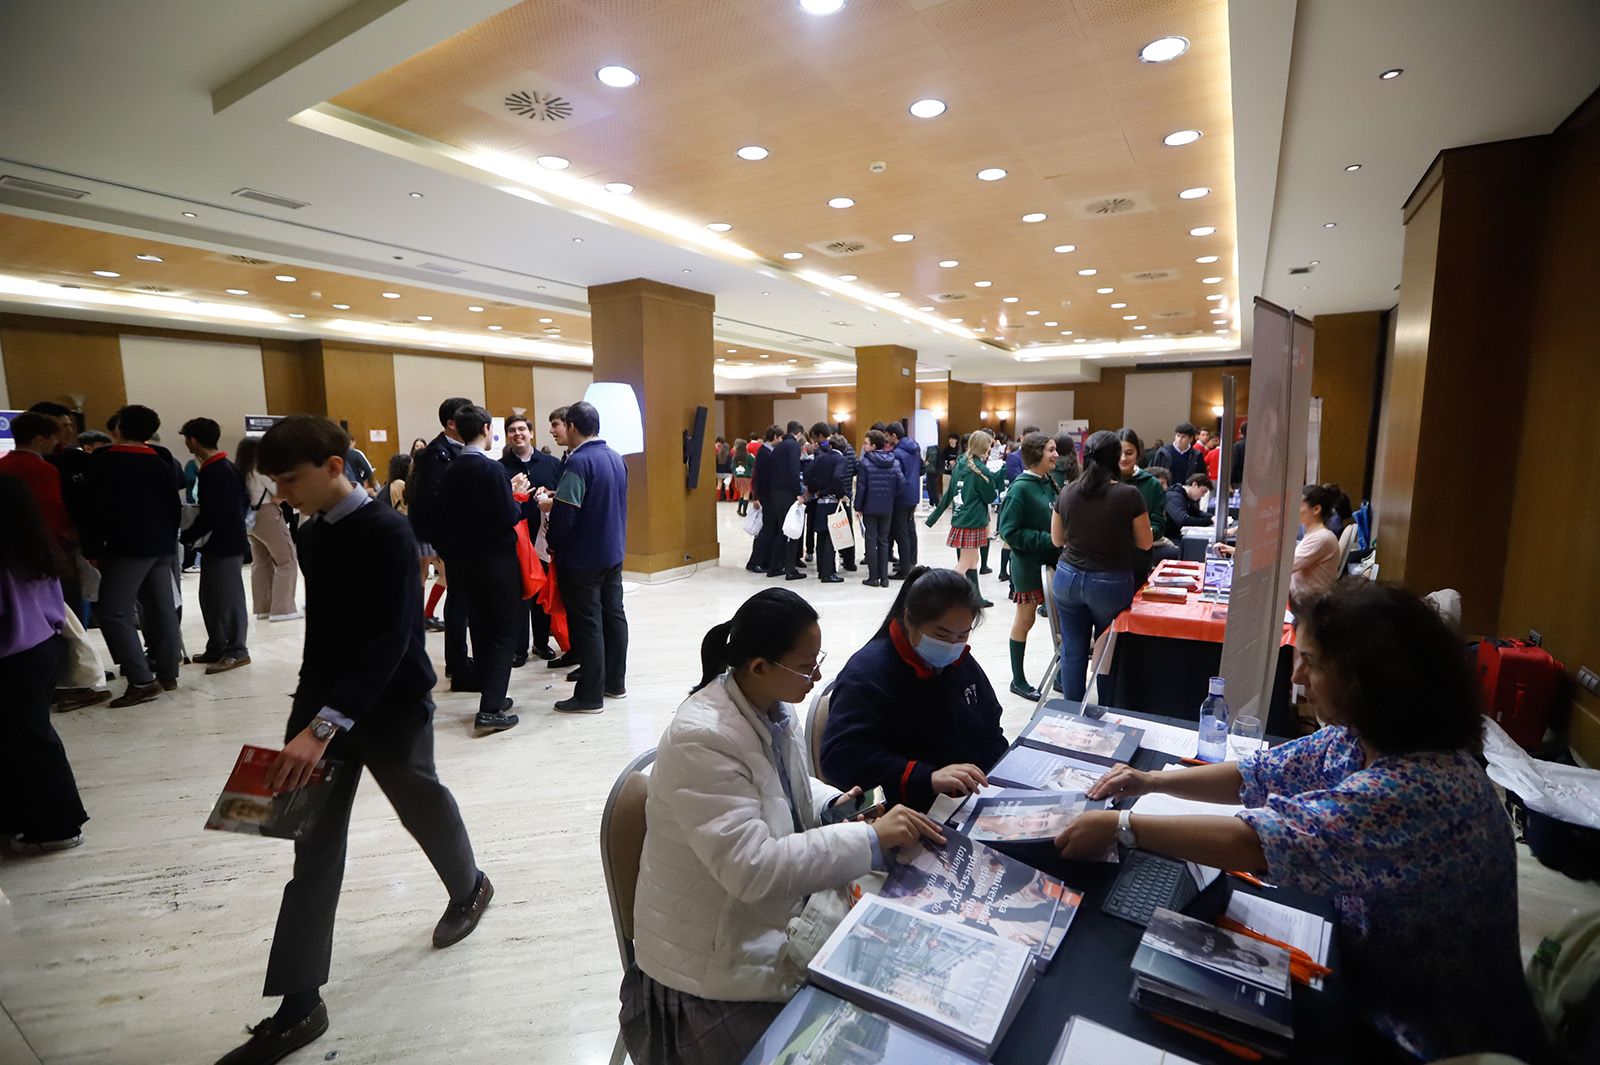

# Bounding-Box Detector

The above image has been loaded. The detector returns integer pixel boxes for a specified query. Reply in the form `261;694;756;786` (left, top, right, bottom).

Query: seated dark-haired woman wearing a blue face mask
822;566;1006;809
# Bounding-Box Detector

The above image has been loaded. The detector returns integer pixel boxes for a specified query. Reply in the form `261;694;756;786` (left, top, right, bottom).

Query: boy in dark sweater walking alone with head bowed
218;414;494;1065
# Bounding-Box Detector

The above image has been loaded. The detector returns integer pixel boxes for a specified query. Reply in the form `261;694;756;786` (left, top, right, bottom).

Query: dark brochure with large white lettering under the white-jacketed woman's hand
880;832;1083;967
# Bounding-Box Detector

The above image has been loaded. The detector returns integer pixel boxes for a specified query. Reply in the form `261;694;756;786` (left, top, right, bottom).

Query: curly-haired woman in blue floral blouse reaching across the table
1056;580;1542;1062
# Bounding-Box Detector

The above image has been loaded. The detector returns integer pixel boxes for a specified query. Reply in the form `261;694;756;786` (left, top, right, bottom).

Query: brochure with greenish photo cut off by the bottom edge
744;987;982;1065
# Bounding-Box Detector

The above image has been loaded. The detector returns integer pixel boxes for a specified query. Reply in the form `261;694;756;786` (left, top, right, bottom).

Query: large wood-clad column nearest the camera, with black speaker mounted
589;278;716;576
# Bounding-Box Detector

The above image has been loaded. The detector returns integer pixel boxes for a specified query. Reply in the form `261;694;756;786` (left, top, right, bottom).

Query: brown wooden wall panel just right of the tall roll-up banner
1310;310;1384;492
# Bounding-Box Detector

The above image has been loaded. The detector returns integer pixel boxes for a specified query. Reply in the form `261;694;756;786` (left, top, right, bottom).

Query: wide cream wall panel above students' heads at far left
120;336;267;444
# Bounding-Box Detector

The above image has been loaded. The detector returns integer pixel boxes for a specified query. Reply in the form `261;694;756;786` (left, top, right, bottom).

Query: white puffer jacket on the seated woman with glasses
634;673;874;1003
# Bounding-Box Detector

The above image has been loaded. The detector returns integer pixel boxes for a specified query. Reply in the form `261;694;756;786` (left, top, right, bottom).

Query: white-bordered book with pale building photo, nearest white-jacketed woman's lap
811;895;1035;1059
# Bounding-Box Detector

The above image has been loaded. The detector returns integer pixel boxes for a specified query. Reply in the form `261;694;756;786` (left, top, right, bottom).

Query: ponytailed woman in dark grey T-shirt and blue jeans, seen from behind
1050;430;1155;700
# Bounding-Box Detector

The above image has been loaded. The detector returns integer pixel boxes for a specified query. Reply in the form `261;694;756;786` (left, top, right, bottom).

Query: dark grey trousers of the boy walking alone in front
261;694;478;995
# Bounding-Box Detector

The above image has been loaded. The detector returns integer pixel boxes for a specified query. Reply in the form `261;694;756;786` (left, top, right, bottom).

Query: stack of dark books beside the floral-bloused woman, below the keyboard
1131;910;1294;1057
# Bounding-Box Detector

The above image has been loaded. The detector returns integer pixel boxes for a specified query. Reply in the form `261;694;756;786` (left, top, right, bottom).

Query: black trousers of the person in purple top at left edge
0;636;90;840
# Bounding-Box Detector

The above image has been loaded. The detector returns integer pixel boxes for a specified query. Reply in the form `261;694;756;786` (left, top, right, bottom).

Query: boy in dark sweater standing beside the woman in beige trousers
178;417;250;675
